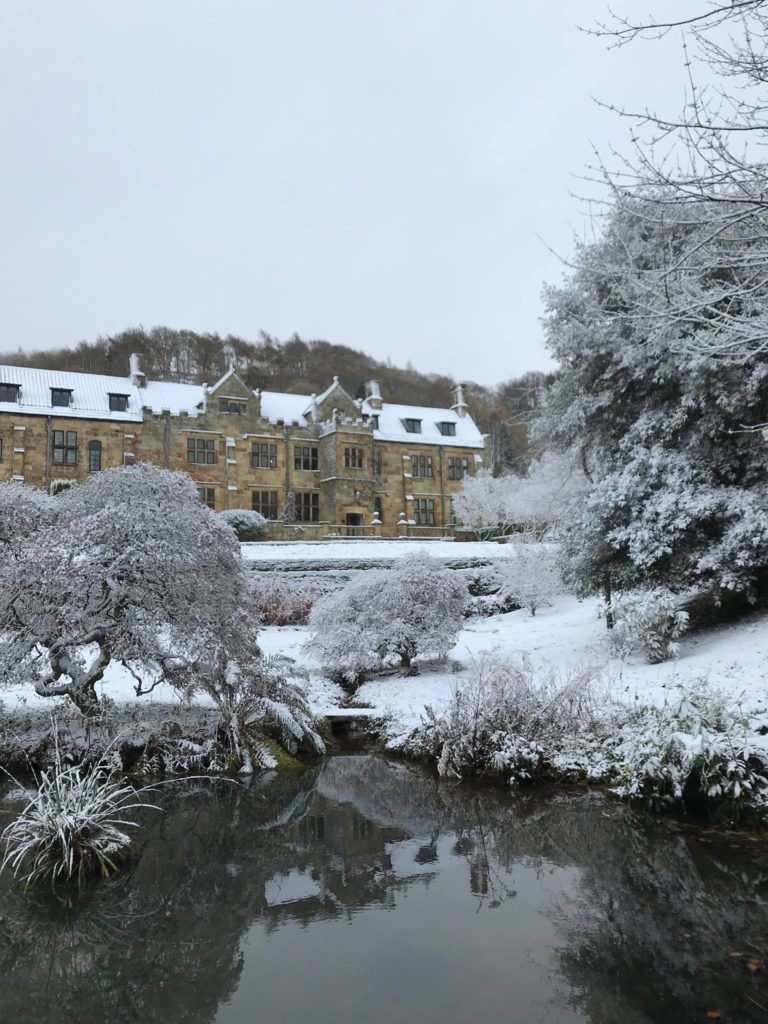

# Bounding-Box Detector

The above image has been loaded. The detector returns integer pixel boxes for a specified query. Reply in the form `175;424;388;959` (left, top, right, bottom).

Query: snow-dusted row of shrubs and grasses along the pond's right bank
399;656;768;820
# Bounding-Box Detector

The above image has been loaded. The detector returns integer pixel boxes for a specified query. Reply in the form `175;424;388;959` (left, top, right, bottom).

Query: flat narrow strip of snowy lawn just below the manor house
241;538;515;562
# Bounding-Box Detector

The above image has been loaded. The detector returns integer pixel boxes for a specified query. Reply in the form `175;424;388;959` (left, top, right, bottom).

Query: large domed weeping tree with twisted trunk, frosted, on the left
0;466;245;715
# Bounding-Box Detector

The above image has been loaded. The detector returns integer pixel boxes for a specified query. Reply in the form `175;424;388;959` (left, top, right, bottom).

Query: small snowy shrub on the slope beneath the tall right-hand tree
609;588;688;665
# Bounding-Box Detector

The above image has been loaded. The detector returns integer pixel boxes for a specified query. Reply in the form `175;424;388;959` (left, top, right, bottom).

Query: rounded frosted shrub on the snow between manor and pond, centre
306;555;467;684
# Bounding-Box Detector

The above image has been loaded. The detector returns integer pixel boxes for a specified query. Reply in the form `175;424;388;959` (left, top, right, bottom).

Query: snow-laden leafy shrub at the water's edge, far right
611;682;768;816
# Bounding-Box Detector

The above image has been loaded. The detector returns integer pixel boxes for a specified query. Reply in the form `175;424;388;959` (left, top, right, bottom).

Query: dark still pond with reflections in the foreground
0;754;768;1024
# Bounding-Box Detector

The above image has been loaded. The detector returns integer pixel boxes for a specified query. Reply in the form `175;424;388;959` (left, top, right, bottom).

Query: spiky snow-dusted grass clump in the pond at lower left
0;762;152;886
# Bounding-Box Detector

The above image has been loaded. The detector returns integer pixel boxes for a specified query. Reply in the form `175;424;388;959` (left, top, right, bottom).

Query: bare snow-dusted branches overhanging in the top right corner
593;0;768;372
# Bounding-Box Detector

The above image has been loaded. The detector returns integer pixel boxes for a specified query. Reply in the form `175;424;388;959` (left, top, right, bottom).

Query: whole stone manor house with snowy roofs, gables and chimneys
0;355;484;537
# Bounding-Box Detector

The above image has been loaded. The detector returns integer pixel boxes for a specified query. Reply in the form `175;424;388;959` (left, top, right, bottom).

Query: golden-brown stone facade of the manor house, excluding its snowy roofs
0;368;483;537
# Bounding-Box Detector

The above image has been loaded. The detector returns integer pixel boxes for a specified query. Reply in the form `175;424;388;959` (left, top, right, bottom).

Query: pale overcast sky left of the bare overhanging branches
0;0;688;383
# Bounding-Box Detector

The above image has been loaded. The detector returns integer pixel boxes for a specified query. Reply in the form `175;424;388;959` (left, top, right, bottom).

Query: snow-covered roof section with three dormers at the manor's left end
0;366;204;423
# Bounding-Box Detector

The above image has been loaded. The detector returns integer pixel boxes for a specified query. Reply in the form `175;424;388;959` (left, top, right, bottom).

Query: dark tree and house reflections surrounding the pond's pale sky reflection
0;756;768;1024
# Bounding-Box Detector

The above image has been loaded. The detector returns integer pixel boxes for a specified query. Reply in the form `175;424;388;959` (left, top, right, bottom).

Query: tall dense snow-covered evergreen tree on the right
538;196;768;603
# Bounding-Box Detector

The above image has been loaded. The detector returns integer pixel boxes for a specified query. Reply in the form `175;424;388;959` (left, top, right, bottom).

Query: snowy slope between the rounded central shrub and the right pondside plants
261;597;768;736
